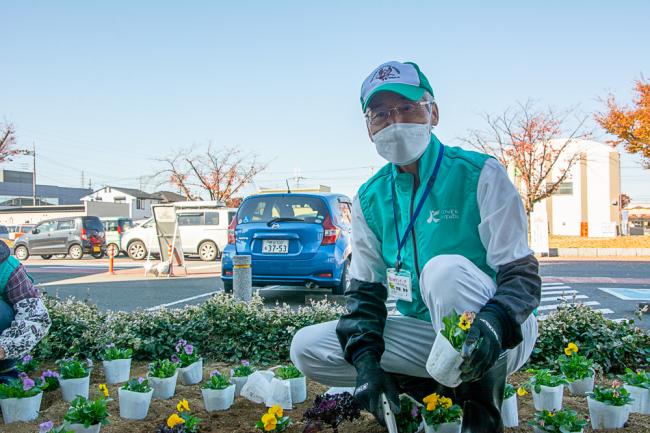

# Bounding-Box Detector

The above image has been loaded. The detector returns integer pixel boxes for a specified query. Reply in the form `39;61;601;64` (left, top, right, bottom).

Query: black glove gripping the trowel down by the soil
354;351;399;425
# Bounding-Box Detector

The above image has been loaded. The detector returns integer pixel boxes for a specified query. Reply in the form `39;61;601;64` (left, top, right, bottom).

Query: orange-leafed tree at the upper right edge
594;79;650;169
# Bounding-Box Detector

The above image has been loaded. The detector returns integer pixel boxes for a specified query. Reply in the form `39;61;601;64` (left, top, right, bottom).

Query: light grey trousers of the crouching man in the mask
291;255;537;386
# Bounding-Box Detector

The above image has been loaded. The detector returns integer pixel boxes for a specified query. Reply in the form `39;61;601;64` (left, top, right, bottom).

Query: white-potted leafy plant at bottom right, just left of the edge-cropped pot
587;380;632;430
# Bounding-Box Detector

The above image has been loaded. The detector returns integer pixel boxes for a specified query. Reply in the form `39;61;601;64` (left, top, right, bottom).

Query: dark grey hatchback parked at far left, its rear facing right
14;216;106;260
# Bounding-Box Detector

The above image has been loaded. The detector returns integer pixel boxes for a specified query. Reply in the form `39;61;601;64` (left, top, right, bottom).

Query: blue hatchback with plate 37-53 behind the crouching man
221;193;352;295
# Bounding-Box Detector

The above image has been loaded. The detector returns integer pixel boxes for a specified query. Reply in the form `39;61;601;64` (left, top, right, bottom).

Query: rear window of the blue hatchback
237;195;328;224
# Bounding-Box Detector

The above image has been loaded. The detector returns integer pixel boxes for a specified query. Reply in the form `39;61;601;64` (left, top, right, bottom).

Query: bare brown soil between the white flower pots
0;363;650;433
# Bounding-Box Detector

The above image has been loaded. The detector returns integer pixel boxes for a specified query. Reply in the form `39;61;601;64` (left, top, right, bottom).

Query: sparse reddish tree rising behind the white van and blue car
156;144;266;202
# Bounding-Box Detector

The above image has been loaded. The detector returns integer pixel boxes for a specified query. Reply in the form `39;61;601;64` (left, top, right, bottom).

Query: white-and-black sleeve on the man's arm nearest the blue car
336;197;388;364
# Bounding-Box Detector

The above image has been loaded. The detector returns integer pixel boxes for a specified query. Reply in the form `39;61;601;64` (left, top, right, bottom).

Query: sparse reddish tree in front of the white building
461;101;590;217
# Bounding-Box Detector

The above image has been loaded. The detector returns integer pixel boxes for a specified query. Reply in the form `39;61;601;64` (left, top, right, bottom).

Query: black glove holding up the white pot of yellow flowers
460;305;504;382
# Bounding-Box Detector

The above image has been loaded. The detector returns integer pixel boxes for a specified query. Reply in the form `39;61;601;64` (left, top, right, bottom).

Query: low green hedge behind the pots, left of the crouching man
35;294;344;364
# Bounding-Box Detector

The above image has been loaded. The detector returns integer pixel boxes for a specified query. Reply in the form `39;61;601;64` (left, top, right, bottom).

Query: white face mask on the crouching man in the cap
372;123;431;165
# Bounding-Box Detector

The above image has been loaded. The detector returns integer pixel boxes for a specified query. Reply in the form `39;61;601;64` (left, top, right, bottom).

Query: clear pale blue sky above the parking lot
0;0;650;202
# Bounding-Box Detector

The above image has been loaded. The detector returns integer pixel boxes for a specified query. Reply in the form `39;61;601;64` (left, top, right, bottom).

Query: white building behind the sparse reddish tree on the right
531;140;621;237
